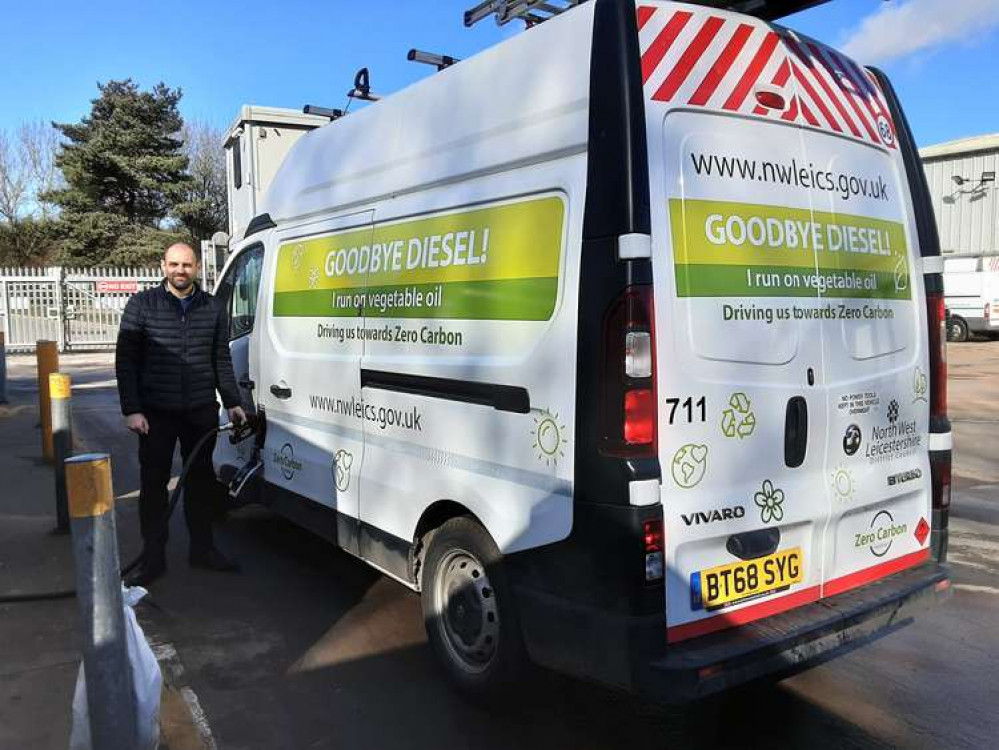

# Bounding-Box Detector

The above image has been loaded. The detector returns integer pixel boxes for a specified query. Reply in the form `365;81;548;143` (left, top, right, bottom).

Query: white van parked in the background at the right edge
944;256;999;341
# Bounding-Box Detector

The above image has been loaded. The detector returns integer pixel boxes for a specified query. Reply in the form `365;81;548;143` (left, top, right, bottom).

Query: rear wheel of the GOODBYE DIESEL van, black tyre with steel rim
422;517;526;700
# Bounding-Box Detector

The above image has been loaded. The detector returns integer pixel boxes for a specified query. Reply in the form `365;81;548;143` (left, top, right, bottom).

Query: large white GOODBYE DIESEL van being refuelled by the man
215;0;951;700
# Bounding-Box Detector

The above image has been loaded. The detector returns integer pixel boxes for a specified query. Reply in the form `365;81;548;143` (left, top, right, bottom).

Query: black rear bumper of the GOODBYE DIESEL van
518;562;950;703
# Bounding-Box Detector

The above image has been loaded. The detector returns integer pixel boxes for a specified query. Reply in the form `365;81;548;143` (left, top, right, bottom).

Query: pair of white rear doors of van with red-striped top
638;3;929;641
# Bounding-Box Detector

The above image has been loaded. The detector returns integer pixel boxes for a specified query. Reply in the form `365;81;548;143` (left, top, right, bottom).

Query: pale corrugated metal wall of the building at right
923;149;999;253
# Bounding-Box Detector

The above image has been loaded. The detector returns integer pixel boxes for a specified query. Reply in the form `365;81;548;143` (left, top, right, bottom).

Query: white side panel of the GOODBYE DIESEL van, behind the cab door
252;8;593;577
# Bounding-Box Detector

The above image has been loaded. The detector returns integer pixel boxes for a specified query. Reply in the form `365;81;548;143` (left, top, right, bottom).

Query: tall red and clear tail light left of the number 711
601;285;659;458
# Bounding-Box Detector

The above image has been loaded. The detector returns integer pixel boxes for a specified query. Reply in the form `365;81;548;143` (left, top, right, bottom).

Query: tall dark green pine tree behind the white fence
46;79;190;264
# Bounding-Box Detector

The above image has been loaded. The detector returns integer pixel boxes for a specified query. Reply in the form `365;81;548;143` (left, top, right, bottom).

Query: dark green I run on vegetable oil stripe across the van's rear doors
676;263;910;299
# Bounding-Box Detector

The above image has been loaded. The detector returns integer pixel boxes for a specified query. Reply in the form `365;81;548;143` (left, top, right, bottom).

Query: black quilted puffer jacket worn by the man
115;282;240;416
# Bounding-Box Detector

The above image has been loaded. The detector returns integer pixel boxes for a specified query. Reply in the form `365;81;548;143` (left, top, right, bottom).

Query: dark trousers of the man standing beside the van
139;406;219;560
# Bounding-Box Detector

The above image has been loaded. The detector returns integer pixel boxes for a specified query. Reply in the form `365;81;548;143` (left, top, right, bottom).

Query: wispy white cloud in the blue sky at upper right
840;0;999;64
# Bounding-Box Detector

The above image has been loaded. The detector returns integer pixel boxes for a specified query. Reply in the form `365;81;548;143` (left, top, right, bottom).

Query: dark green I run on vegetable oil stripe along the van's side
274;277;558;320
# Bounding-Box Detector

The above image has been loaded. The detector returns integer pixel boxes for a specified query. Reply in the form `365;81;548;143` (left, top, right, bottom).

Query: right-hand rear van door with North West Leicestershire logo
785;33;931;596
